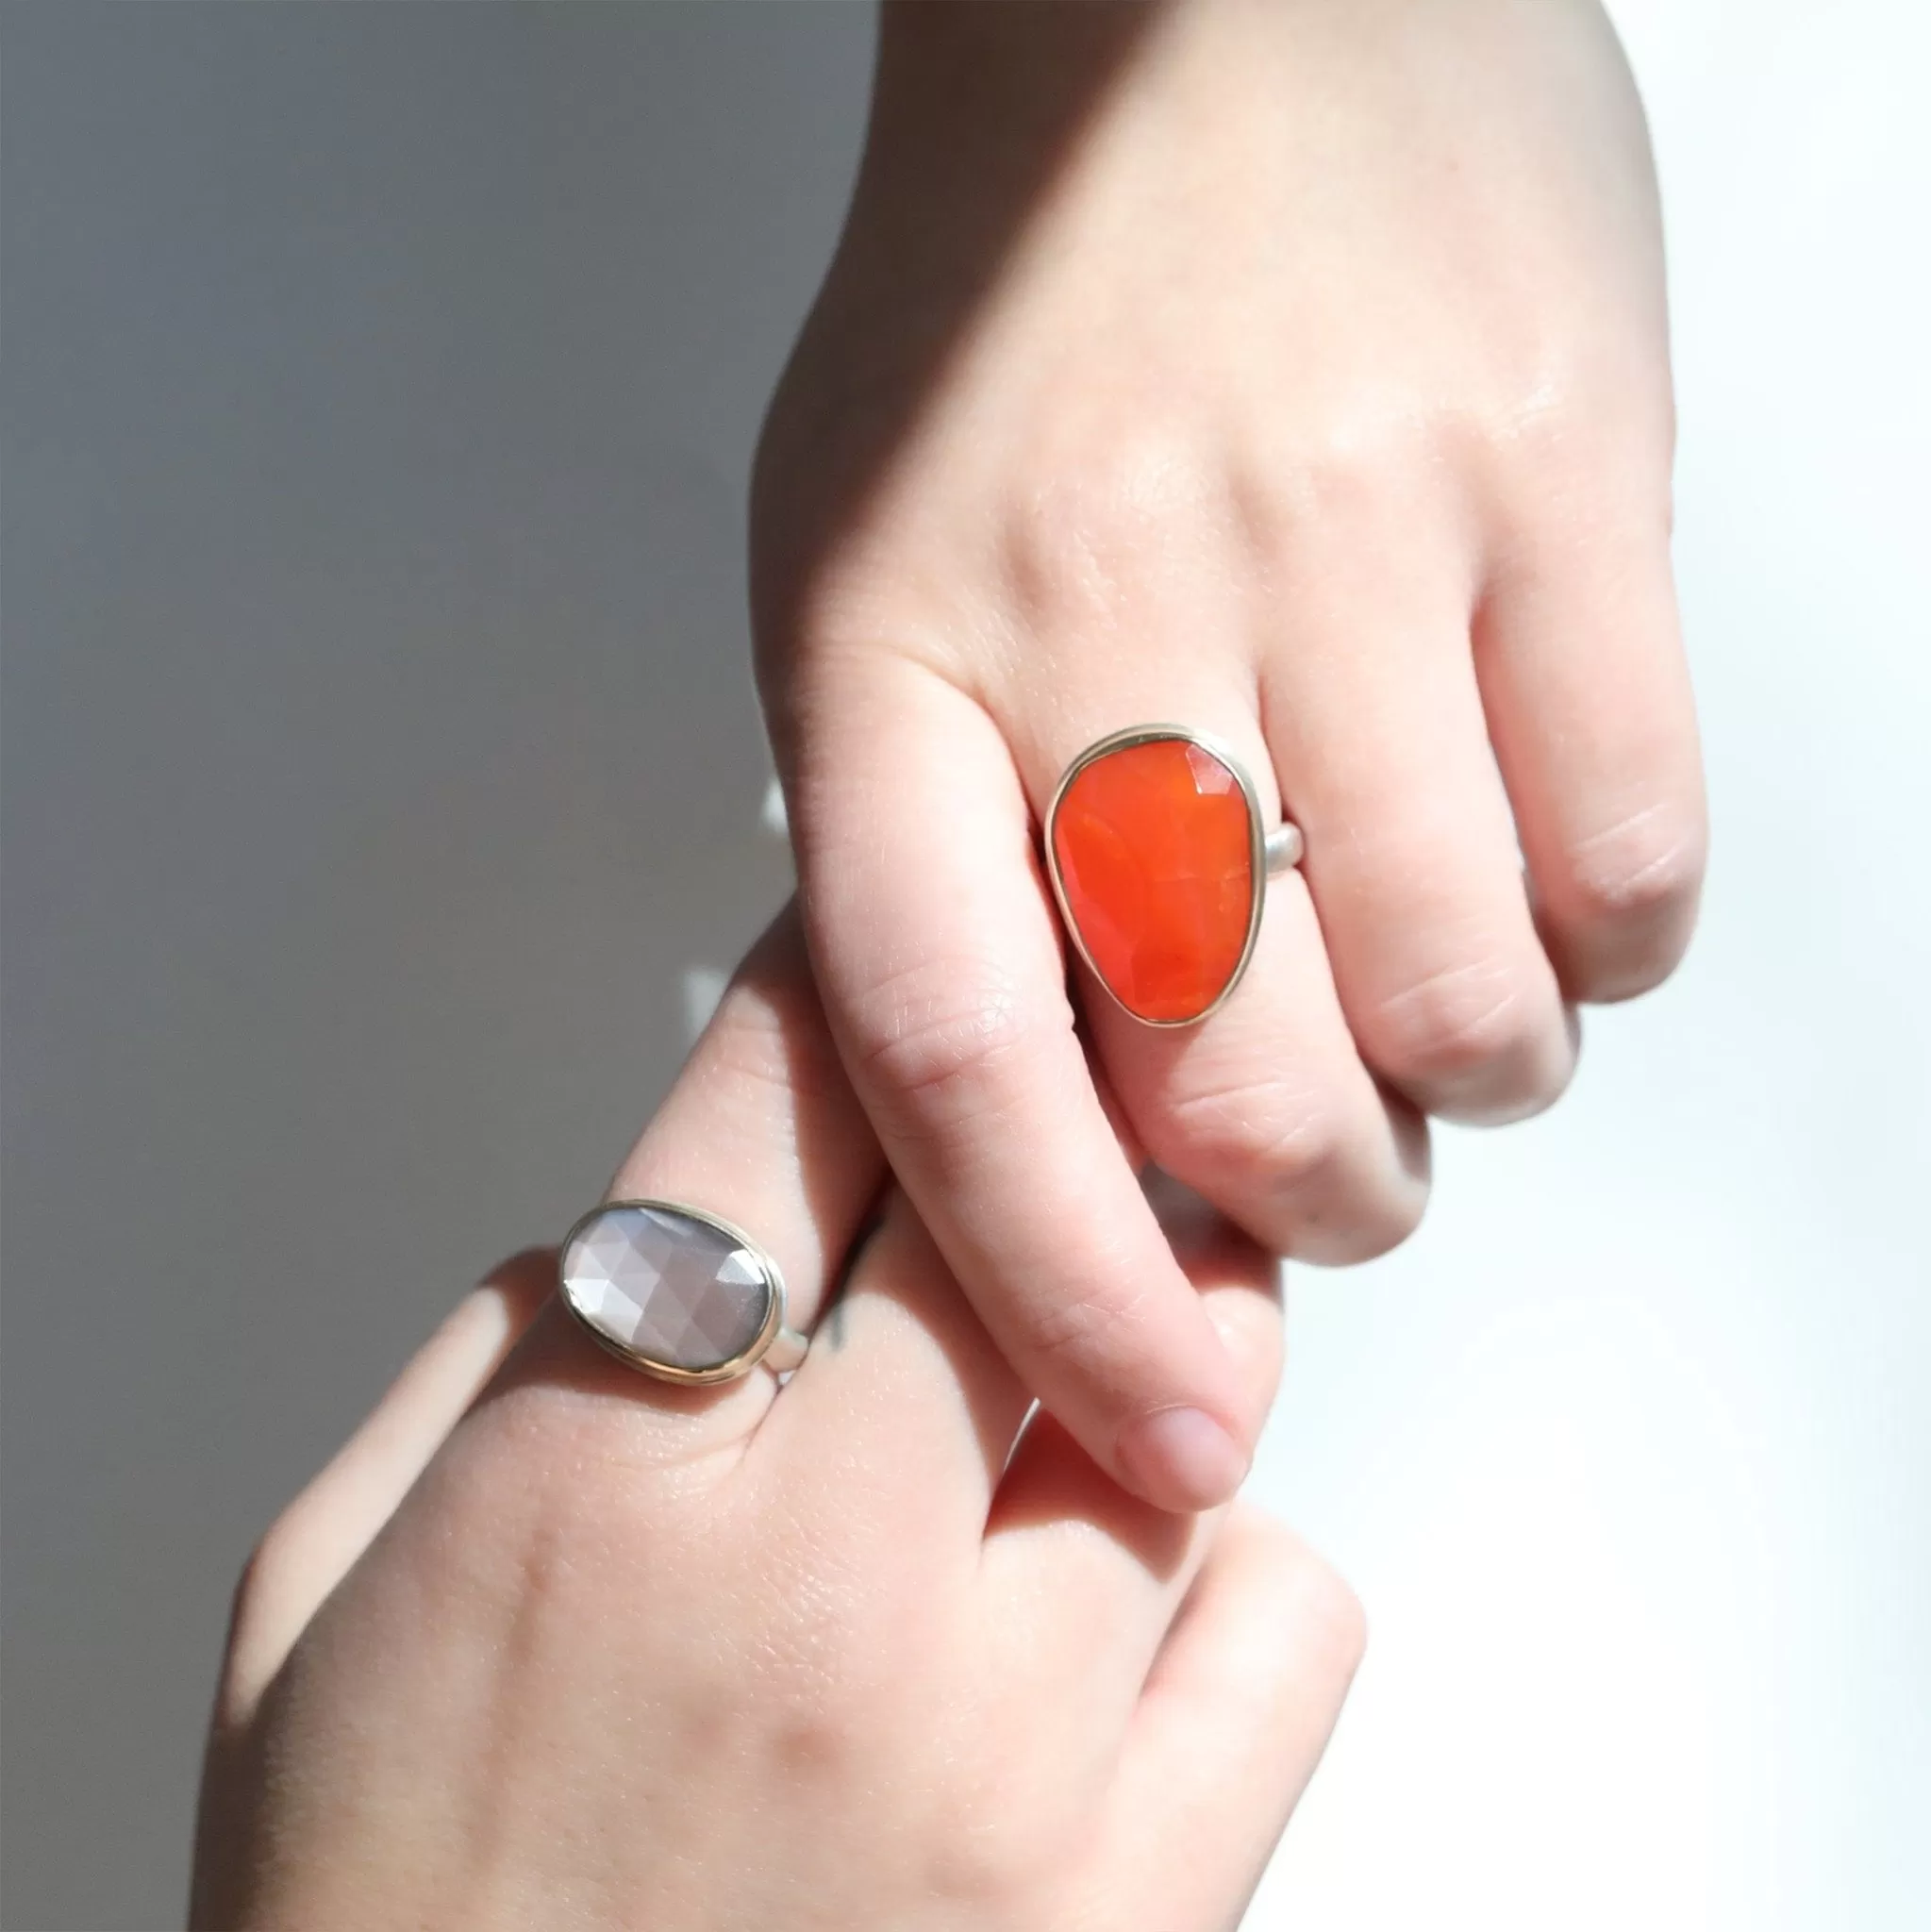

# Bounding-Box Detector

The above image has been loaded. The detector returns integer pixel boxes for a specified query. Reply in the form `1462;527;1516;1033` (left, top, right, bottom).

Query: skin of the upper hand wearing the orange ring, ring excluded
751;0;1706;1508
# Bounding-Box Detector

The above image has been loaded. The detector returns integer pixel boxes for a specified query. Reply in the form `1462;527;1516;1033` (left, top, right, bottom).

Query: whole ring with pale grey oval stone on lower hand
558;1198;809;1385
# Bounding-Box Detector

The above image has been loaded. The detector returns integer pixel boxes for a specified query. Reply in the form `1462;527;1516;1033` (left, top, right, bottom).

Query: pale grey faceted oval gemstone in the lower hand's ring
562;1206;776;1375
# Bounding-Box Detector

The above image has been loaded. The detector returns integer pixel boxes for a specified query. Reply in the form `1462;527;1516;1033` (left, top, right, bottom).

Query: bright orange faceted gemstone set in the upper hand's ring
1053;738;1257;1022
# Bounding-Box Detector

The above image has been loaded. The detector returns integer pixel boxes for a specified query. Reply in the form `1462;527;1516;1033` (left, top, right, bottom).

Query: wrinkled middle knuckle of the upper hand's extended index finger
848;960;1072;1132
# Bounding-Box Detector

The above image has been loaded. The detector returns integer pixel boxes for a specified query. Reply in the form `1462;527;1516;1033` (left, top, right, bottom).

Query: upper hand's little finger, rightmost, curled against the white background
1475;525;1707;1001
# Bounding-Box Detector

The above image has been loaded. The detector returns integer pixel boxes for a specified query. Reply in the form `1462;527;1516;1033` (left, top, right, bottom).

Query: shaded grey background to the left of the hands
0;0;871;1928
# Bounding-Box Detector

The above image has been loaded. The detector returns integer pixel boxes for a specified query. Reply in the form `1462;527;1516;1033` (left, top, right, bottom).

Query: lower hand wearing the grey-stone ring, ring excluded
193;911;1361;1932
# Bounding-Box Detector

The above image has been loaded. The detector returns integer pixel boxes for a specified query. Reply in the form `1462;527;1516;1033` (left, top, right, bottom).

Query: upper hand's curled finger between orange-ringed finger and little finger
1263;512;1575;1121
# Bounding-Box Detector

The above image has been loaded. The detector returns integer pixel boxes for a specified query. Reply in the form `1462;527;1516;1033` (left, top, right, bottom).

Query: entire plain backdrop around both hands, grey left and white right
0;0;1931;1932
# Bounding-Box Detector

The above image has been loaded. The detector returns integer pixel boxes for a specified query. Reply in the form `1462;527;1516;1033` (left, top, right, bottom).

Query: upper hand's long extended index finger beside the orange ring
790;657;1259;1508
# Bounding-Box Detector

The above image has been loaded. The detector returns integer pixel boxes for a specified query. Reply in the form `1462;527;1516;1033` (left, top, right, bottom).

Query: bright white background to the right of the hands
1249;0;1931;1932
